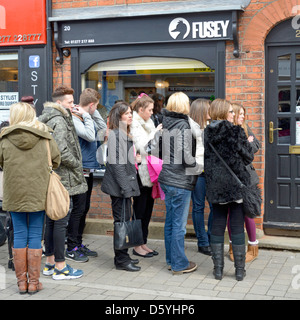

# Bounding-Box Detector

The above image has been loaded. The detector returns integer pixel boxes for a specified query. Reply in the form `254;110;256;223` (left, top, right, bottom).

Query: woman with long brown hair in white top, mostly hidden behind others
189;99;212;255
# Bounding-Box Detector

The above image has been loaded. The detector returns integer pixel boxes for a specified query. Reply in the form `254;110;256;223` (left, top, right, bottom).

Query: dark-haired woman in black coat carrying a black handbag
101;102;141;271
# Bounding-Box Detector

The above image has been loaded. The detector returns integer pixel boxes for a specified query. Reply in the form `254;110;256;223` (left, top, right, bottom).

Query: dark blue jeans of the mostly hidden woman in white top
192;175;213;247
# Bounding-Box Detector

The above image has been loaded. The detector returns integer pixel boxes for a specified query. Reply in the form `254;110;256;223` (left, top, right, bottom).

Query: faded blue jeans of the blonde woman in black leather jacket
160;183;191;271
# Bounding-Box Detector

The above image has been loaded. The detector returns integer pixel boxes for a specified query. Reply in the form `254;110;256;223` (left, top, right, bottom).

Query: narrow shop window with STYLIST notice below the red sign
0;53;19;123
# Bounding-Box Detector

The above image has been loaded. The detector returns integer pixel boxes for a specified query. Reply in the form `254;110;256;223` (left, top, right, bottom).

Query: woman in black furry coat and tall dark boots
204;99;253;281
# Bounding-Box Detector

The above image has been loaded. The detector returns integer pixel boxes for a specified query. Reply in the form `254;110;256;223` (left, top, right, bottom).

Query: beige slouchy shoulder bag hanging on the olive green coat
45;140;70;220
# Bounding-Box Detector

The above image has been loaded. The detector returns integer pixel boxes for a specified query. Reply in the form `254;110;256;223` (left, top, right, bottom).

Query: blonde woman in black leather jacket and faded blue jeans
158;92;199;274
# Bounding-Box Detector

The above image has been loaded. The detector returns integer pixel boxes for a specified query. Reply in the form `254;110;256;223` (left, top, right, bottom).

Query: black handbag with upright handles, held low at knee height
114;198;144;250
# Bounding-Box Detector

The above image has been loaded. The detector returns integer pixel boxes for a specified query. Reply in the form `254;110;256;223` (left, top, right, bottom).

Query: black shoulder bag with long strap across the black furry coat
209;143;262;219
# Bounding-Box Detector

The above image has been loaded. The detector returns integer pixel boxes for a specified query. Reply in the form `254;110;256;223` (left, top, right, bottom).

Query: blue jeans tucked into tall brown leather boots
10;211;45;249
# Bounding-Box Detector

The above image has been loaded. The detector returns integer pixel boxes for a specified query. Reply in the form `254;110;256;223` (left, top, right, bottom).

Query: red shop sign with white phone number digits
0;0;47;46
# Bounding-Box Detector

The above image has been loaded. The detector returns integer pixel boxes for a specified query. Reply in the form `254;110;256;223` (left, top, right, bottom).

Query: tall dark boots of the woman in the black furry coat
210;243;246;281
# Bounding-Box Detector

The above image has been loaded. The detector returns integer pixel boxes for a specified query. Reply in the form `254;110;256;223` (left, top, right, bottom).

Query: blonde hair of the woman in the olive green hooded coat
9;102;48;132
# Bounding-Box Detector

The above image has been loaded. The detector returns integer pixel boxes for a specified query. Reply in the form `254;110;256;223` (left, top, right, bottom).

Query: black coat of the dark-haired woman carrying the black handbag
101;130;140;198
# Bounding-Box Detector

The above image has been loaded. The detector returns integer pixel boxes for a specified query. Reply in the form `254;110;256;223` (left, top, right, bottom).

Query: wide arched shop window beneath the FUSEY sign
82;57;215;112
